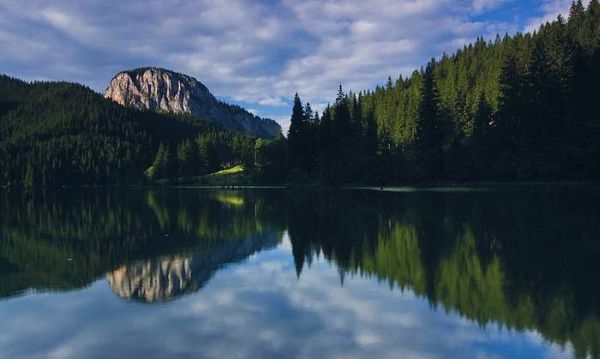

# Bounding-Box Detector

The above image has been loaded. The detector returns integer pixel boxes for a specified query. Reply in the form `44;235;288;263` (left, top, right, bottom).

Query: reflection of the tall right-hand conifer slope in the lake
289;190;600;358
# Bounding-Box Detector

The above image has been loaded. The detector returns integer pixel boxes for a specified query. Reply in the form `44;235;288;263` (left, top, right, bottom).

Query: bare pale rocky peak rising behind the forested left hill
104;67;281;138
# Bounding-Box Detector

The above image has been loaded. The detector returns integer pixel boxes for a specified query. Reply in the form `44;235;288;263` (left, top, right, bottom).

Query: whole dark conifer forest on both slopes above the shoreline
0;0;600;187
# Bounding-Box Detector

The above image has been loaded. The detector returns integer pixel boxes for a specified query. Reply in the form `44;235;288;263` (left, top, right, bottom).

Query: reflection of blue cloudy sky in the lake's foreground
0;244;568;358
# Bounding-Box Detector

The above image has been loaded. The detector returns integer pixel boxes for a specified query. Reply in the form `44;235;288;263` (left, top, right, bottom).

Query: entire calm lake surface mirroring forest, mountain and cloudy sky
0;186;600;359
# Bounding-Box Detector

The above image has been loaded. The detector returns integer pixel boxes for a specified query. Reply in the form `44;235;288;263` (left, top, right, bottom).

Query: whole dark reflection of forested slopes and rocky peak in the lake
0;187;600;358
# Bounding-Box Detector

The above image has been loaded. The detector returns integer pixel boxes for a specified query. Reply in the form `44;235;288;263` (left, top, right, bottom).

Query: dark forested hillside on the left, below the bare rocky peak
0;75;254;187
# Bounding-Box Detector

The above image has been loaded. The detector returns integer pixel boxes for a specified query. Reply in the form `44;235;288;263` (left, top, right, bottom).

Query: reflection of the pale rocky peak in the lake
107;234;279;303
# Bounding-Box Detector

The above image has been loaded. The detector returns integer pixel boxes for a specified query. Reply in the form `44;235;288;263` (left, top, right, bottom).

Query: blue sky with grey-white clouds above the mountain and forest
0;0;571;131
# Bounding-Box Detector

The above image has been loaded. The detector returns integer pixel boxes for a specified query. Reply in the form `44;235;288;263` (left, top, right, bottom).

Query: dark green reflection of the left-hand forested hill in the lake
0;190;283;297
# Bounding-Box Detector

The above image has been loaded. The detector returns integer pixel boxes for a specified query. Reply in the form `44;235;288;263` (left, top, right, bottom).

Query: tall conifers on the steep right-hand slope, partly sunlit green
281;0;600;183
